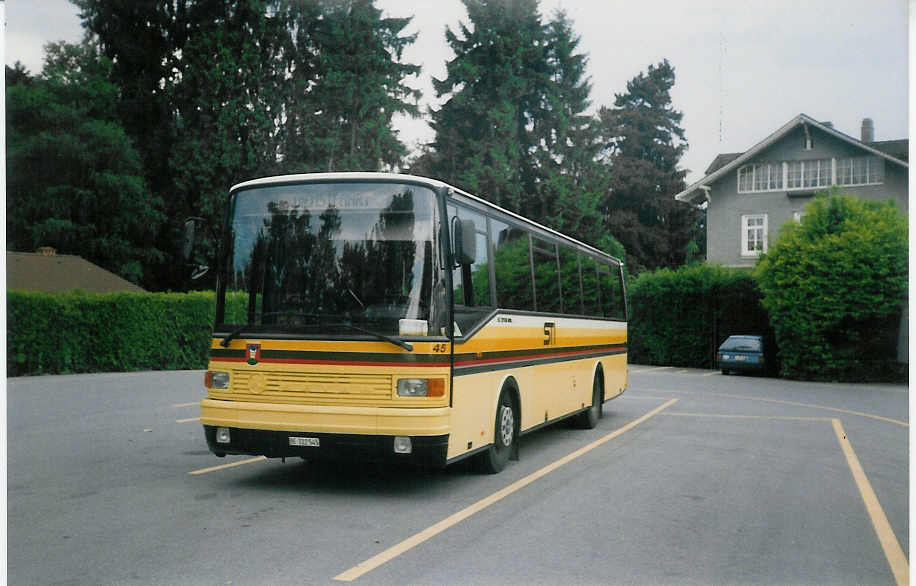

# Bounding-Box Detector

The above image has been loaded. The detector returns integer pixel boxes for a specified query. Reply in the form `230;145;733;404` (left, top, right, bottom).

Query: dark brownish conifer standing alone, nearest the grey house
599;60;698;271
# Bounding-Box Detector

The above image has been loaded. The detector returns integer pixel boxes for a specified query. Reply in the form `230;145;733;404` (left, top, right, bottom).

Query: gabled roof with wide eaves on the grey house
674;114;909;202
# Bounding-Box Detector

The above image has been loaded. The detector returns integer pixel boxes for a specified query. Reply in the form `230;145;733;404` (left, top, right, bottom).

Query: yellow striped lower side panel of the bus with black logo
448;313;626;459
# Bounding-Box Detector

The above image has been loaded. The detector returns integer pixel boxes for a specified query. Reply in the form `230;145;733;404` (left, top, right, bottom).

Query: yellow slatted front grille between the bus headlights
232;370;392;406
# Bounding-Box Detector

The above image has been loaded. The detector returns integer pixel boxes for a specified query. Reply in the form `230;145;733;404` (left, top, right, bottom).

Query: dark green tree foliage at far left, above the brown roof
6;43;164;284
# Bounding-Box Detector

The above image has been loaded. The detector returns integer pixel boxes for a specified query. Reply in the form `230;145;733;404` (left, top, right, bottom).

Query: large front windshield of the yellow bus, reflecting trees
216;182;447;337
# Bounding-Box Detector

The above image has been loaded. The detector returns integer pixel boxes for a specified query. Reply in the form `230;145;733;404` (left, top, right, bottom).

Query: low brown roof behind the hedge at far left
6;252;144;293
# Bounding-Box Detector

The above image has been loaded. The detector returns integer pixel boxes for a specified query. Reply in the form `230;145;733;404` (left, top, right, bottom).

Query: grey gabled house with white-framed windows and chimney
675;114;909;267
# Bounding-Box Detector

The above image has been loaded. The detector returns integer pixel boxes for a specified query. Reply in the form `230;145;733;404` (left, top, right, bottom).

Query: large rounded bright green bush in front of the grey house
755;190;907;380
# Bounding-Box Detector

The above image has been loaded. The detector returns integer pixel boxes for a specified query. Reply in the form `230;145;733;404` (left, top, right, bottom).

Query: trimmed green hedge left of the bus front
6;291;214;376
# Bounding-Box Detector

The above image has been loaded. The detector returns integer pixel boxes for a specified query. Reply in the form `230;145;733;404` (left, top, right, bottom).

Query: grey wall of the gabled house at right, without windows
706;126;907;267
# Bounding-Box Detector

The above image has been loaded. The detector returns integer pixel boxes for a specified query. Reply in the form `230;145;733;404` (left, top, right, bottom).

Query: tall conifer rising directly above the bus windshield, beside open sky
285;0;420;171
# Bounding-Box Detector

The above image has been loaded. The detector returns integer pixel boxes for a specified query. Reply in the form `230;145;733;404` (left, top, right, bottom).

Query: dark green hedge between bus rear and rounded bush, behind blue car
628;265;770;368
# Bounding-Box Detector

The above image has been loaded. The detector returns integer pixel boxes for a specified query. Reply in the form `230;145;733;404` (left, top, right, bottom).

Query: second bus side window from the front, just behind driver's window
490;220;534;311
